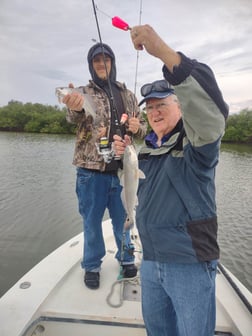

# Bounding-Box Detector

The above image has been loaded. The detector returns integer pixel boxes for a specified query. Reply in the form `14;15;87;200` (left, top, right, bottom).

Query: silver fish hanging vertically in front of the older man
118;144;145;231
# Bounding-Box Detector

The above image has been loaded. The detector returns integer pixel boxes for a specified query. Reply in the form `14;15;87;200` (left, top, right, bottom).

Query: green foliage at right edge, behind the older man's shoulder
222;109;252;143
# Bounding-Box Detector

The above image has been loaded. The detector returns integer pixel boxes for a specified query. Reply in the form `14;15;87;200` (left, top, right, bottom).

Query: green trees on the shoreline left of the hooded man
0;100;75;134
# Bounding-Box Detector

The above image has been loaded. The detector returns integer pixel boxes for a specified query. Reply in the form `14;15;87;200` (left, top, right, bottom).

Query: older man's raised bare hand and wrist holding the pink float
130;25;181;72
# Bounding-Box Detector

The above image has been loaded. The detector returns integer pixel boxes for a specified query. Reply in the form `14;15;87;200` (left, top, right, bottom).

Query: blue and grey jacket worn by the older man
136;53;228;263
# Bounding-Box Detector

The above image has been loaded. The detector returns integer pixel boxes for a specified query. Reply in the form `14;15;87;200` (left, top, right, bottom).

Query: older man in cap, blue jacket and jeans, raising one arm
114;25;228;336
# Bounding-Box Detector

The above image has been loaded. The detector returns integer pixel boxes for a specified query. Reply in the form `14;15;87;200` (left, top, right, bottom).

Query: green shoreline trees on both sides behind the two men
0;100;252;144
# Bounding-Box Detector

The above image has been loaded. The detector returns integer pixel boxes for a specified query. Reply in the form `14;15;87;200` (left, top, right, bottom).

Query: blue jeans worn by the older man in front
141;260;217;336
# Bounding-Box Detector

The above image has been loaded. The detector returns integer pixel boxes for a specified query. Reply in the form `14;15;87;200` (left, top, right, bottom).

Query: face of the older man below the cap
146;95;181;139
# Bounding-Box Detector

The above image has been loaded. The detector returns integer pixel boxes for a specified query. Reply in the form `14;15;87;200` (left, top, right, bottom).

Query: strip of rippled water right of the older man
216;144;252;291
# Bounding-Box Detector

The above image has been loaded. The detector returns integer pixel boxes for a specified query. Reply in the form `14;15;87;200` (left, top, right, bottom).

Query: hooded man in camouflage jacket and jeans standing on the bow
63;43;146;289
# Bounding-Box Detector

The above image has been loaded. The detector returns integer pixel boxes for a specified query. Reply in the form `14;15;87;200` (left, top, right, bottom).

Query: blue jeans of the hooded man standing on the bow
76;168;134;272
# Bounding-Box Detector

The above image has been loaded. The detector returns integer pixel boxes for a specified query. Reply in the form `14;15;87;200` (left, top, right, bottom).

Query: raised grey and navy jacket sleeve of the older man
163;53;228;147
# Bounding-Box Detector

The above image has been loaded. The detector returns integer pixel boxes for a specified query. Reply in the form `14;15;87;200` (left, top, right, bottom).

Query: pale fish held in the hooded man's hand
55;87;96;119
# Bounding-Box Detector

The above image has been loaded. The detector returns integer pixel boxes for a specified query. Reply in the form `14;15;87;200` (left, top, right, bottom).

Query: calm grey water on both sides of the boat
0;132;252;296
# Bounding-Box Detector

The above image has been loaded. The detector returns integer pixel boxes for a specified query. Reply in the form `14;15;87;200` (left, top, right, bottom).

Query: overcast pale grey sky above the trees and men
0;0;252;112
